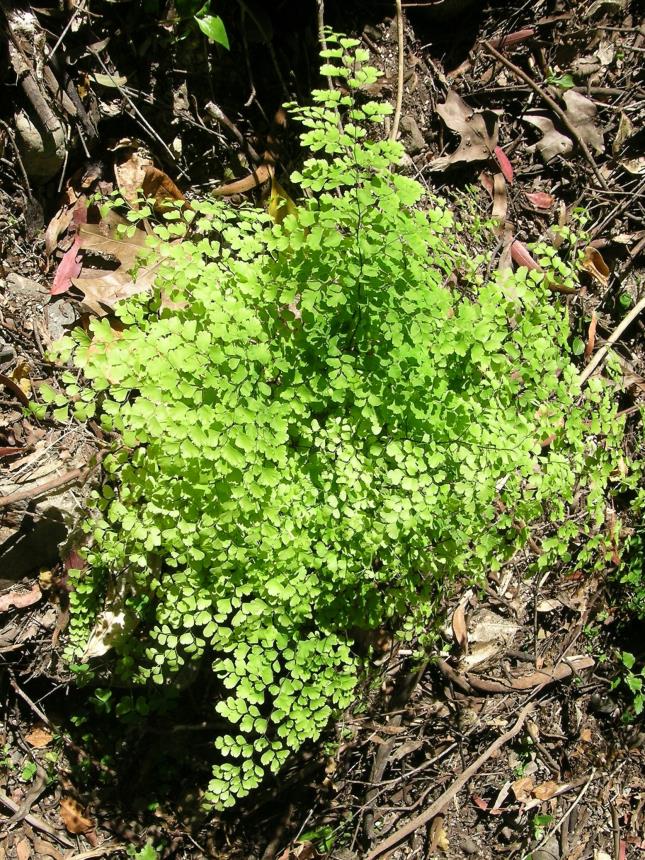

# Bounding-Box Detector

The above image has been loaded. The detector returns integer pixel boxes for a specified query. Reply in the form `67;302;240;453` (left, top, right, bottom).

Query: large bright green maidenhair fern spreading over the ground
54;35;621;808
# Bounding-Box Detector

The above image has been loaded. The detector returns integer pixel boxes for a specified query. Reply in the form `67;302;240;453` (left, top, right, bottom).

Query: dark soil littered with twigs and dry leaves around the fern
0;0;645;860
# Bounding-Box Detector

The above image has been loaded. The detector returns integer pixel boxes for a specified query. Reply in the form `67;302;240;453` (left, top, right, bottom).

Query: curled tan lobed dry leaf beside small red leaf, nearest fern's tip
428;90;498;170
